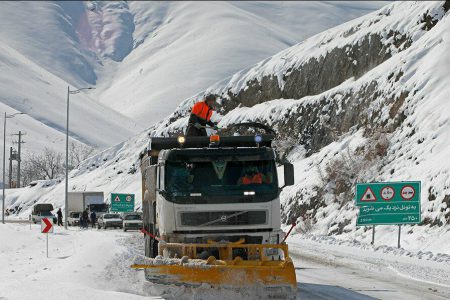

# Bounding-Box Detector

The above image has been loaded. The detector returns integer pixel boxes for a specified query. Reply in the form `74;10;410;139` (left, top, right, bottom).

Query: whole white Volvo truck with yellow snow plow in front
132;134;297;299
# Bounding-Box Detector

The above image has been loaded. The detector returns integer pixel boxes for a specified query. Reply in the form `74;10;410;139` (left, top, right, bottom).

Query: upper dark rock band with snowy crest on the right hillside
156;2;442;120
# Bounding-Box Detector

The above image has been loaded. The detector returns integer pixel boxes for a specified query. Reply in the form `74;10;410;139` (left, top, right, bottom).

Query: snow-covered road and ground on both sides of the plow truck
0;223;450;300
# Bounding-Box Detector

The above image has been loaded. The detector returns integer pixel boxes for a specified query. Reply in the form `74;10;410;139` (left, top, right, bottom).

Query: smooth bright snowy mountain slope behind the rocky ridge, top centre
95;2;385;125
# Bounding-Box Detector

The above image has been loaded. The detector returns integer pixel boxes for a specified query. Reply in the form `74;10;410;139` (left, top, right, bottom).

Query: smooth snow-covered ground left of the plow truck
0;224;155;299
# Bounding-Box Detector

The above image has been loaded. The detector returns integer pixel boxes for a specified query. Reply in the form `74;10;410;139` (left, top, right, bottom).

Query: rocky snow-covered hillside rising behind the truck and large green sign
7;2;450;251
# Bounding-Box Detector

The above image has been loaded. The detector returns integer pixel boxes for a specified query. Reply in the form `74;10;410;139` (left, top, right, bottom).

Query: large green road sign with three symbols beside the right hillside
356;181;421;226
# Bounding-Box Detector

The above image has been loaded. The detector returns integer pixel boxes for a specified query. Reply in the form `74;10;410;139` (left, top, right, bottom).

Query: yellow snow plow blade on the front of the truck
132;243;297;299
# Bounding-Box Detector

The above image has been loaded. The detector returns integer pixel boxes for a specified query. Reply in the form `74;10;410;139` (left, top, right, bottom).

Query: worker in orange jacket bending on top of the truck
186;95;218;136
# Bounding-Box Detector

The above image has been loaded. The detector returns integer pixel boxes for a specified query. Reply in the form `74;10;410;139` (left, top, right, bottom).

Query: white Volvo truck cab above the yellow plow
141;135;293;257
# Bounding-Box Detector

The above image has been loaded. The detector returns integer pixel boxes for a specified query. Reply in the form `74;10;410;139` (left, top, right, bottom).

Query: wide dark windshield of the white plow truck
165;160;278;203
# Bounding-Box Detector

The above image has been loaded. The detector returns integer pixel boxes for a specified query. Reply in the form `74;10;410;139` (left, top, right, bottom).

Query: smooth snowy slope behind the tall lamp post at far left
0;45;141;149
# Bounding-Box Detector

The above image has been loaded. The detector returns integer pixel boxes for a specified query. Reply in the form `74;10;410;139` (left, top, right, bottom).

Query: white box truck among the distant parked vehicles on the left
68;192;108;218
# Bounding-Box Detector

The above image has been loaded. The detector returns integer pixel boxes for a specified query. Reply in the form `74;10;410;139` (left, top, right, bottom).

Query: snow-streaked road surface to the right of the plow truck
290;239;450;300
